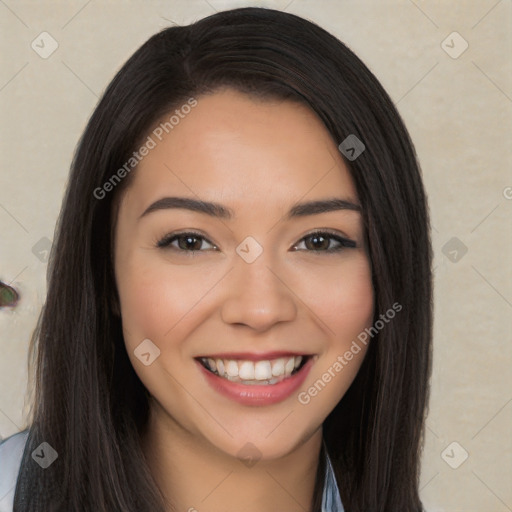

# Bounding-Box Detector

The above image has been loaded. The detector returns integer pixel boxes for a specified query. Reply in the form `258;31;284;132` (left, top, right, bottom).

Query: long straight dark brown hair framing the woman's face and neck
14;8;432;512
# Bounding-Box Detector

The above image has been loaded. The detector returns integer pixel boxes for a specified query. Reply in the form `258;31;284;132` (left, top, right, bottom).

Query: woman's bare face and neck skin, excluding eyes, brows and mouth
114;89;373;512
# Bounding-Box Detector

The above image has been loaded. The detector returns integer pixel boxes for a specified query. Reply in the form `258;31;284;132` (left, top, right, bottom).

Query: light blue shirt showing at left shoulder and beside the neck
0;430;345;512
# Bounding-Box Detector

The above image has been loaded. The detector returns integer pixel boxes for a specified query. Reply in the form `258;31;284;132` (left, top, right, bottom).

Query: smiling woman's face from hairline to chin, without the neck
115;90;373;459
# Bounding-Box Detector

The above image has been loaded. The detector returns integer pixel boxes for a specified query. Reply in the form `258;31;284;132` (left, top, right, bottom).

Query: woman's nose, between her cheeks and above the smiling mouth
221;252;297;331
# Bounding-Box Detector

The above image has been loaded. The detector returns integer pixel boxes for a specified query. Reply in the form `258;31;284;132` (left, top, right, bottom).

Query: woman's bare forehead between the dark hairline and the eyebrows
121;90;357;212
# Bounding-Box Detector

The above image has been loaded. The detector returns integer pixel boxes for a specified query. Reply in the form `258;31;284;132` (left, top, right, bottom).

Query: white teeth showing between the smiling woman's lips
196;355;311;386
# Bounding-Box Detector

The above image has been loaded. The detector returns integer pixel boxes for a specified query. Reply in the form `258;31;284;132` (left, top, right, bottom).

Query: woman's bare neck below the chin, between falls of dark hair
142;403;322;512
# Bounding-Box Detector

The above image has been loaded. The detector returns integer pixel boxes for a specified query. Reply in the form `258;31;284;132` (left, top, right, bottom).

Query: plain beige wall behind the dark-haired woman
0;0;512;512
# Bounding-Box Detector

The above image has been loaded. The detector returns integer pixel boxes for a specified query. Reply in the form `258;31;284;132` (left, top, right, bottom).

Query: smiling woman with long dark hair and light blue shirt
0;8;432;512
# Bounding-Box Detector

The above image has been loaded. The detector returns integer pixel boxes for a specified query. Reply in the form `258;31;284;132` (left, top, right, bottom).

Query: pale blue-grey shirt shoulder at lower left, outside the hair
0;430;28;512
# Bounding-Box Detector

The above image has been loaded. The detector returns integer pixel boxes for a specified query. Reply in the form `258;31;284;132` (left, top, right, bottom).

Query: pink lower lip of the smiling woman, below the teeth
196;357;313;405
